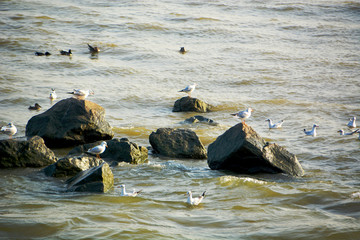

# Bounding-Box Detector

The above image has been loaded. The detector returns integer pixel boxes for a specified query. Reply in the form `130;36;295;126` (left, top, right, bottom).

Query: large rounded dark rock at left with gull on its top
26;98;114;147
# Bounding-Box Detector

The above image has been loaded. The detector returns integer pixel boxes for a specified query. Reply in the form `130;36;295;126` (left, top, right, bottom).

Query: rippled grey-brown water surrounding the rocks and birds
0;0;360;239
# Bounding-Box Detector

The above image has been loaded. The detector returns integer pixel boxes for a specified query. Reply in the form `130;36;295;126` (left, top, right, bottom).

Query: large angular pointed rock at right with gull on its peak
208;123;304;176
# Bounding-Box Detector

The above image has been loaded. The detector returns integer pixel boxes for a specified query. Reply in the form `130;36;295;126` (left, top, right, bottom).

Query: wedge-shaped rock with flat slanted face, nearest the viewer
66;162;114;192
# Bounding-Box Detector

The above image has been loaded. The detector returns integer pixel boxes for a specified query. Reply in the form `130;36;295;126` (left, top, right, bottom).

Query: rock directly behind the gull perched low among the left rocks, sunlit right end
68;138;148;164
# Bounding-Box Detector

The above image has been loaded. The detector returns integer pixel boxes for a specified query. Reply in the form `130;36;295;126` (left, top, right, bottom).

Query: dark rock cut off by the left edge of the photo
0;136;57;168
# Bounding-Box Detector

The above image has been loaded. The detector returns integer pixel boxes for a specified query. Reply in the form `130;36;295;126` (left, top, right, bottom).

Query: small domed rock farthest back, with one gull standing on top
173;97;211;113
